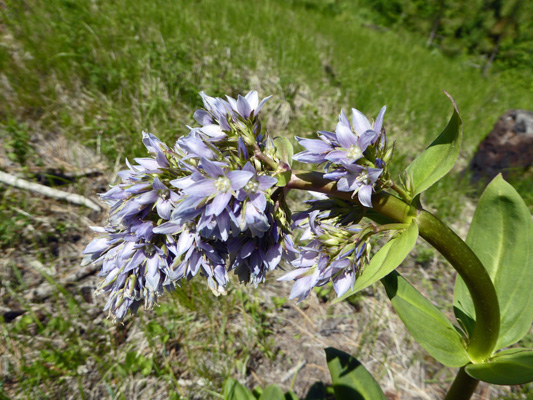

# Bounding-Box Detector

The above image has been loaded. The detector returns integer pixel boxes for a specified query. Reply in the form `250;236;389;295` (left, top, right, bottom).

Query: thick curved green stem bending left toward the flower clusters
288;172;500;362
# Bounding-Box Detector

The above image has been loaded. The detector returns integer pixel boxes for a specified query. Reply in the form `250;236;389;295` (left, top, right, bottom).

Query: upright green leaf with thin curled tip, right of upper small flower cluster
406;92;463;197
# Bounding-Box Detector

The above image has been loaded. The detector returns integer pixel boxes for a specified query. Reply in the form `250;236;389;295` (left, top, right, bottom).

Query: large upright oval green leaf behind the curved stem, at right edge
454;175;533;350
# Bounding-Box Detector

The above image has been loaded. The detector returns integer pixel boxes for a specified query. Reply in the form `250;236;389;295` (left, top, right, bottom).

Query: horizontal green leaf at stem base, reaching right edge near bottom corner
465;349;533;385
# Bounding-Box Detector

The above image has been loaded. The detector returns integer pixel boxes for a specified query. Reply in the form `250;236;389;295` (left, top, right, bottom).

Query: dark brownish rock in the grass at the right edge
470;110;533;181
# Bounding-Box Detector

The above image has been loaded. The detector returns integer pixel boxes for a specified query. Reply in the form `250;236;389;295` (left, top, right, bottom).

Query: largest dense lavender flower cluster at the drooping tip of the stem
84;91;295;320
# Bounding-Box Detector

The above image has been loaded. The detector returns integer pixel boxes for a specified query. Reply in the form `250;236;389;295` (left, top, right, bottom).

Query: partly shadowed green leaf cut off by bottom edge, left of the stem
325;347;386;400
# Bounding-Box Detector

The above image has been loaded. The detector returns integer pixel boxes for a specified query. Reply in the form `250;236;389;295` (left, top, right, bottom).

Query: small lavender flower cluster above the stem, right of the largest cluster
293;107;392;207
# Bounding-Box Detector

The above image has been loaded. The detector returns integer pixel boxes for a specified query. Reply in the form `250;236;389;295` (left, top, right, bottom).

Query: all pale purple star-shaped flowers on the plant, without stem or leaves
83;91;391;320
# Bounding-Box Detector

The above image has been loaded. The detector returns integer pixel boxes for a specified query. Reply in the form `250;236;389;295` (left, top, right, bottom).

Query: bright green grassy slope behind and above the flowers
4;0;533;216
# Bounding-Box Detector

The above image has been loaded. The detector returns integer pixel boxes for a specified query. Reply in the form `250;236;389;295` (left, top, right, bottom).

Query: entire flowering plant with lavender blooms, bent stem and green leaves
84;91;533;400
